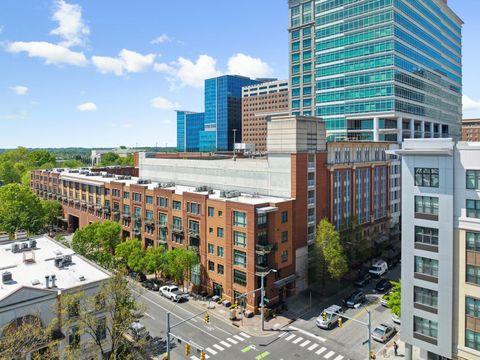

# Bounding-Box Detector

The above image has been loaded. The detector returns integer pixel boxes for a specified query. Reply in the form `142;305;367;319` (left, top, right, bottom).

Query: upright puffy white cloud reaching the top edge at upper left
50;0;90;47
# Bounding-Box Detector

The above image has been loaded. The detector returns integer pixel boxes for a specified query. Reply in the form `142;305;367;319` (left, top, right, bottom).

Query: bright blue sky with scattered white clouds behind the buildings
0;0;480;148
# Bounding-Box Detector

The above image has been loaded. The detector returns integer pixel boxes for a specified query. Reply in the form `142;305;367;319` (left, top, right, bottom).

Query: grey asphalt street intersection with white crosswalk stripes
131;266;400;360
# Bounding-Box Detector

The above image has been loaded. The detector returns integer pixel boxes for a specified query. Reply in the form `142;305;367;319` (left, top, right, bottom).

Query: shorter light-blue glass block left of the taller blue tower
177;111;205;152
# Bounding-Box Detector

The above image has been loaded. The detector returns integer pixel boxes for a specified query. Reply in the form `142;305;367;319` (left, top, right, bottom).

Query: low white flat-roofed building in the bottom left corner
0;234;110;359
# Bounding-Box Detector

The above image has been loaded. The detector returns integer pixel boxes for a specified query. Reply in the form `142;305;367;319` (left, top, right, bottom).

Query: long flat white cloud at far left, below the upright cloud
6;41;88;66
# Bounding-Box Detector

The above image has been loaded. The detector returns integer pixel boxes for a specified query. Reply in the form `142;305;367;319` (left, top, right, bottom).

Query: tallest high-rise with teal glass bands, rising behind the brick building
288;0;463;142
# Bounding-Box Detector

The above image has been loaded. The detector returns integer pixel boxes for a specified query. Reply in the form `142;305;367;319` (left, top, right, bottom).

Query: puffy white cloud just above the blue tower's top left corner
154;55;221;87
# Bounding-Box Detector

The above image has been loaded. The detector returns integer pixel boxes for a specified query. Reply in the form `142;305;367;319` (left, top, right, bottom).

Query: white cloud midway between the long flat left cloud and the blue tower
92;49;156;76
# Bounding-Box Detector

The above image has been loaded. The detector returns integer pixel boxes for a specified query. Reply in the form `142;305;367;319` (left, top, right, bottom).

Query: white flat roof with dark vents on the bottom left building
0;235;110;301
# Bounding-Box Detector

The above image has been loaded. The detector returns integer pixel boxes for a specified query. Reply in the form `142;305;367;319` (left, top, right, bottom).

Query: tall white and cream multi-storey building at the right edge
397;139;480;360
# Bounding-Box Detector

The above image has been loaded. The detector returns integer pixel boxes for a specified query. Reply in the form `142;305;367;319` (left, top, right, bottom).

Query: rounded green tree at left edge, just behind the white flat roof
0;184;45;234
